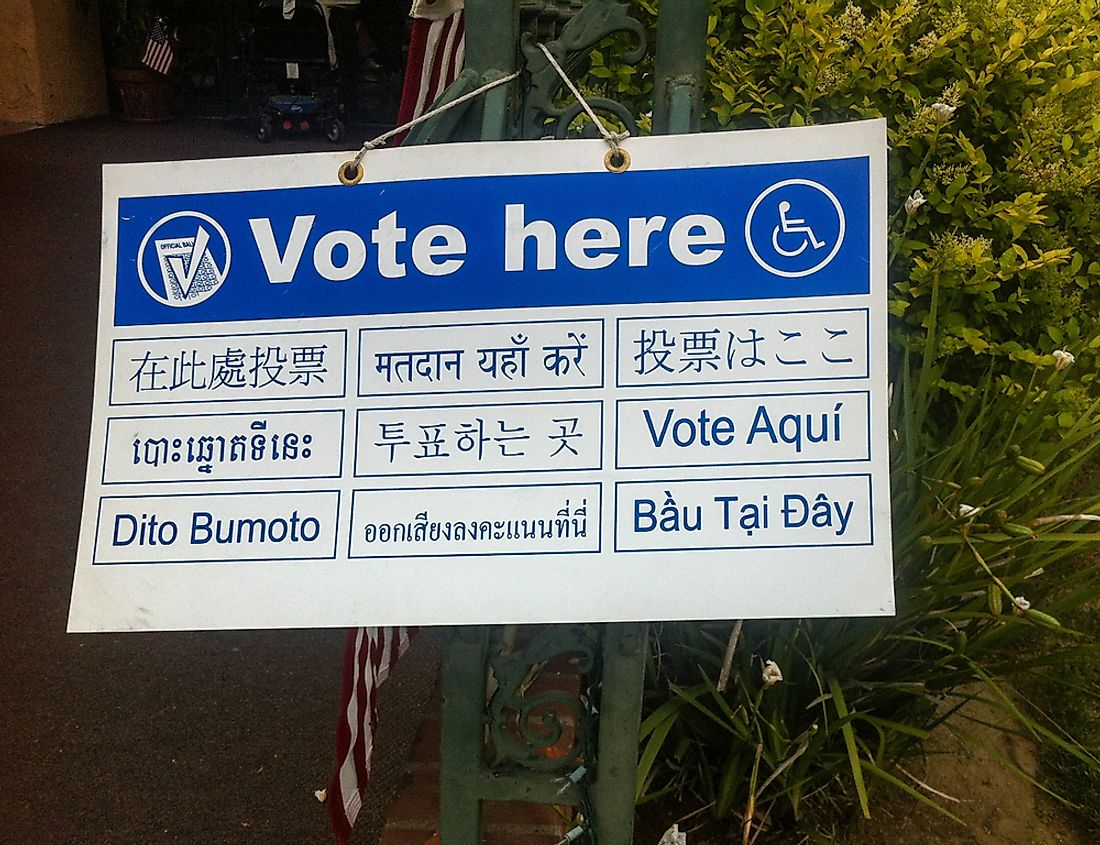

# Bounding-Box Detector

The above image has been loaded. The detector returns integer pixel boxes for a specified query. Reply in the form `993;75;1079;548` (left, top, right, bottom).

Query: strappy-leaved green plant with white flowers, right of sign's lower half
638;360;1100;841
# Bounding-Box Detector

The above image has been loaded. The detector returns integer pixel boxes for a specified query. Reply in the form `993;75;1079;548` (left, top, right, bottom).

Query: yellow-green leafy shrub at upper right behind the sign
707;0;1100;413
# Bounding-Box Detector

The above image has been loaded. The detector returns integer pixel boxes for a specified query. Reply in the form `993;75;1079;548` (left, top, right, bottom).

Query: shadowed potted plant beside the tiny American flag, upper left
100;0;173;122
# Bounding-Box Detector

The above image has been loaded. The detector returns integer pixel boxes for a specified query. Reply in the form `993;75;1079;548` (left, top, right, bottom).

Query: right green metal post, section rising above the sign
653;0;707;135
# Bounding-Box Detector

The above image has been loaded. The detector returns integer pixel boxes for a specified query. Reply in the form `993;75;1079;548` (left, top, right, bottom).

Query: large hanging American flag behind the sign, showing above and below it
326;0;465;845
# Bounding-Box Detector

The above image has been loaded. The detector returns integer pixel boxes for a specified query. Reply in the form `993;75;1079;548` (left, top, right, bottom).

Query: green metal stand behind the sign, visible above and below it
424;0;707;845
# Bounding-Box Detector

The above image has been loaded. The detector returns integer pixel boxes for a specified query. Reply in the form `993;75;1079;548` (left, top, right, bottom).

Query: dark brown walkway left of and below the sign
0;119;436;845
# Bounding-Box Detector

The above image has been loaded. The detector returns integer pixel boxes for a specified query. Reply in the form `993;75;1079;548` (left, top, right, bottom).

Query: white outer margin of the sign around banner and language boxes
69;121;893;632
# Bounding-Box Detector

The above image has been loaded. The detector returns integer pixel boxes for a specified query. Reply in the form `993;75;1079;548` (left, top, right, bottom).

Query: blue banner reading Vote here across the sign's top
114;157;870;326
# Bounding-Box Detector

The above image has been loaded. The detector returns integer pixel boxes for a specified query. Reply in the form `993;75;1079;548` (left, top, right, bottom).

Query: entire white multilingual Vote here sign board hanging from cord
69;121;893;632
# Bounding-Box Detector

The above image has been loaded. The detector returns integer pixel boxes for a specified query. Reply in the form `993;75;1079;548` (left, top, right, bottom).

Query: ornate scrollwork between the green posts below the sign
487;625;600;772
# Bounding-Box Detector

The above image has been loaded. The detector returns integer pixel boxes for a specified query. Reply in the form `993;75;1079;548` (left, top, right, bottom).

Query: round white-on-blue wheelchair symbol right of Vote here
745;179;845;278
